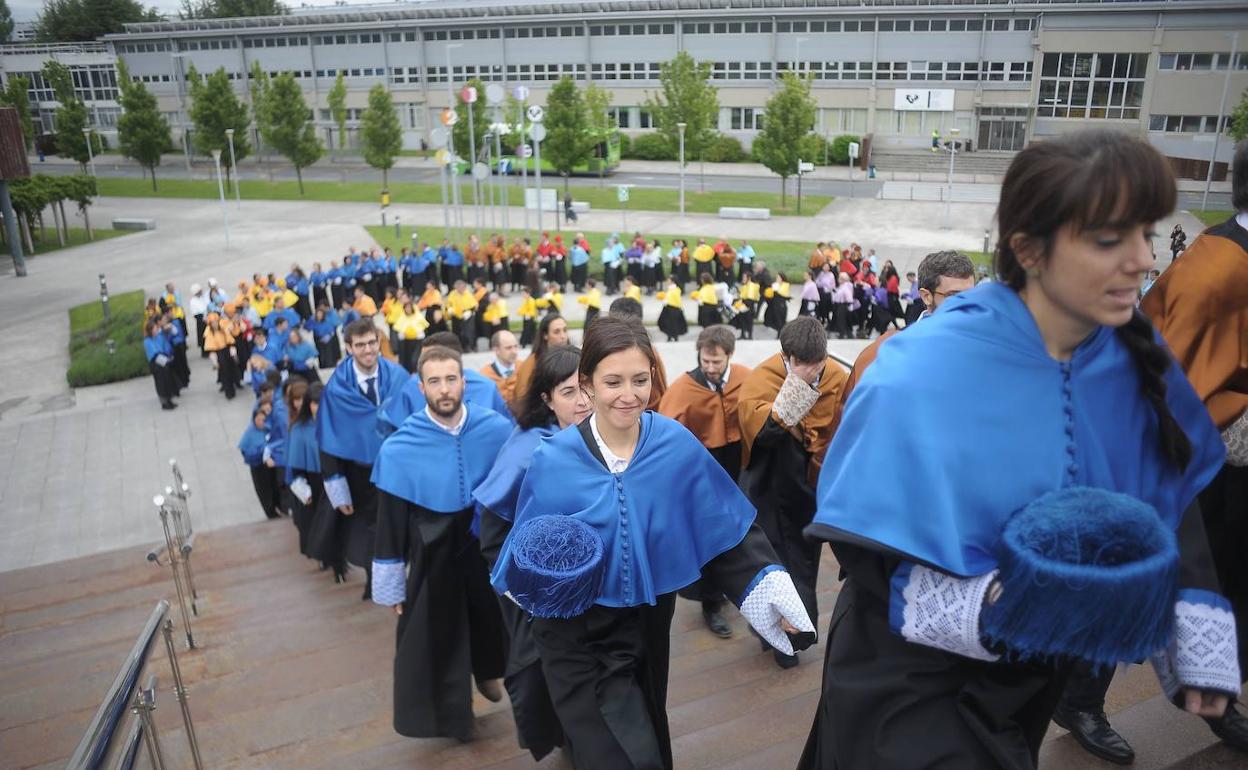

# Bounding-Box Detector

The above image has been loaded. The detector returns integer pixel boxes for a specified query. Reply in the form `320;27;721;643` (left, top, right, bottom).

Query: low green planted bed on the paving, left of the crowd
65;287;147;388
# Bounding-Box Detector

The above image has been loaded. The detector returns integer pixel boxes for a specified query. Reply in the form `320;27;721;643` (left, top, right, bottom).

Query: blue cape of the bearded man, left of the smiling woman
372;404;512;513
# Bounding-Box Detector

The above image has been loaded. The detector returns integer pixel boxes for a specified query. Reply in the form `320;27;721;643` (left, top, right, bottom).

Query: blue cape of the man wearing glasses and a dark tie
316;356;407;465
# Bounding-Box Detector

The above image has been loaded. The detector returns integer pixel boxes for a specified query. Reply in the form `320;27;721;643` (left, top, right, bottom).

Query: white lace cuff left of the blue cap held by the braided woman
889;563;1000;660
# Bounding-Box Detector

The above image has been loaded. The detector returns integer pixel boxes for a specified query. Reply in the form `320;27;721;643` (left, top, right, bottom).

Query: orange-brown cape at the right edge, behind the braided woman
1139;218;1248;429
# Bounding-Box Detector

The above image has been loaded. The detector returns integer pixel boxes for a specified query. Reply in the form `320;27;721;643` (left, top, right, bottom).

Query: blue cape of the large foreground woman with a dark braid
807;283;1226;577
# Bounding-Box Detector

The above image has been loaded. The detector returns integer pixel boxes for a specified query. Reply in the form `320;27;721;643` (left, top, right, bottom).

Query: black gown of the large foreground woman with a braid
797;503;1217;770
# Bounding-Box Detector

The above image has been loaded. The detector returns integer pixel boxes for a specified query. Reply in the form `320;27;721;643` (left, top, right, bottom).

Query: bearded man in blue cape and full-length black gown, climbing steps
372;346;512;741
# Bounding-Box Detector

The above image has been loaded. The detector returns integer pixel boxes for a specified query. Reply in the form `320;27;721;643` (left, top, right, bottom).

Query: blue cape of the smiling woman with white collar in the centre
490;412;755;607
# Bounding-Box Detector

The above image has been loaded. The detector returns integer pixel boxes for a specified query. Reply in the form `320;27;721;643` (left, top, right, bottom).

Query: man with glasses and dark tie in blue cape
312;318;407;599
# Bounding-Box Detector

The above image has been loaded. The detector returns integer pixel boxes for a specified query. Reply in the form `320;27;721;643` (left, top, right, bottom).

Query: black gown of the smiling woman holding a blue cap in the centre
533;421;779;770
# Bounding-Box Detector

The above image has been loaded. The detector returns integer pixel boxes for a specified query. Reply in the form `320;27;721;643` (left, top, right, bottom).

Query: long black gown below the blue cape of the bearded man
376;490;507;739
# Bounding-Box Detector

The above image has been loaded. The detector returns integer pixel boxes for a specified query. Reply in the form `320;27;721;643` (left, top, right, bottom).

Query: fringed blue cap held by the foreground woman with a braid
981;487;1178;665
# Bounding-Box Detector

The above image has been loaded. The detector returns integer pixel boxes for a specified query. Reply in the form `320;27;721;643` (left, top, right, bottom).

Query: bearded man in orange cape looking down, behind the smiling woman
659;323;750;639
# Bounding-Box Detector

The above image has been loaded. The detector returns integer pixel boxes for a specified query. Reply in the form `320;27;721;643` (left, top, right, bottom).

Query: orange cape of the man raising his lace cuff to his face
738;353;847;484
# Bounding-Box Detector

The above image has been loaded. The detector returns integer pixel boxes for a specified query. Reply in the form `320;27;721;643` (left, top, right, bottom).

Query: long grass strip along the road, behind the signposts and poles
96;177;834;216
